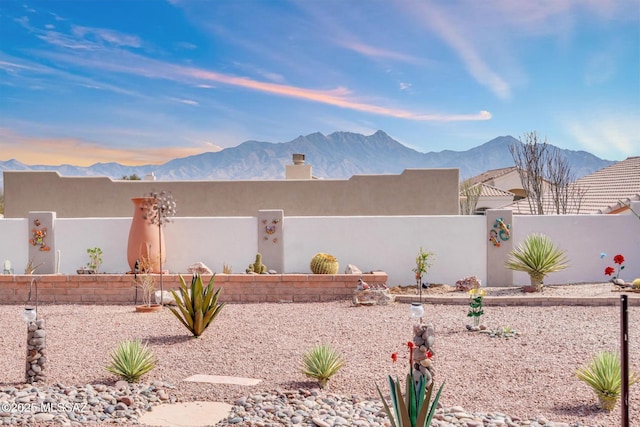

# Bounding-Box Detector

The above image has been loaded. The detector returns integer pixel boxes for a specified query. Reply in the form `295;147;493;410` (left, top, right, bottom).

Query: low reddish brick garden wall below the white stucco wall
0;272;387;304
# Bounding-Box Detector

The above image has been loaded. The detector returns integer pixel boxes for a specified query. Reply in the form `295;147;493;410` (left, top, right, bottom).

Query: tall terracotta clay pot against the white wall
127;197;167;273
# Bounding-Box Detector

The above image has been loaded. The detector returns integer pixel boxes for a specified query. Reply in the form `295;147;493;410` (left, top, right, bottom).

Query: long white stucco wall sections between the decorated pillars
0;202;640;285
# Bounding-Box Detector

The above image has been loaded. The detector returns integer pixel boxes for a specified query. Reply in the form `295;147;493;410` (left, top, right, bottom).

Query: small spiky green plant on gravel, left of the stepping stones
105;340;156;383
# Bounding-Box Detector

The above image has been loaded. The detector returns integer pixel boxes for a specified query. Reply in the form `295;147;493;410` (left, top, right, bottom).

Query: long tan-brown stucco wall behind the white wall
4;169;459;218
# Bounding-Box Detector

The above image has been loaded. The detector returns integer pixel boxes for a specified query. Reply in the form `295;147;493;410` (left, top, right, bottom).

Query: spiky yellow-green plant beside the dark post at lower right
576;351;640;411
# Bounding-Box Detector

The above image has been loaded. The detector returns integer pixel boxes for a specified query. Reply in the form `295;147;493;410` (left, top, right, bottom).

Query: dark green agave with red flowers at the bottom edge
376;342;444;427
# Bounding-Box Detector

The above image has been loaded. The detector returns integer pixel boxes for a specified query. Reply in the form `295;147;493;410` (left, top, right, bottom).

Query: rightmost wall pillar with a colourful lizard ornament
485;209;513;286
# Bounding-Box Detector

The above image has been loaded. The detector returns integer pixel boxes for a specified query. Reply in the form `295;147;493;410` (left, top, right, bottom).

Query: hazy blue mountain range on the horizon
0;131;613;190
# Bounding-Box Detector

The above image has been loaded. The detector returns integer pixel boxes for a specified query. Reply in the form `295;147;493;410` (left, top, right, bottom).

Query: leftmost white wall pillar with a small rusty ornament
25;212;56;274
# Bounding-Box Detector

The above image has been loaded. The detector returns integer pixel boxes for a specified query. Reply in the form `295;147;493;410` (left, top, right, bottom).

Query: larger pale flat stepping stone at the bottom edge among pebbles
139;402;232;427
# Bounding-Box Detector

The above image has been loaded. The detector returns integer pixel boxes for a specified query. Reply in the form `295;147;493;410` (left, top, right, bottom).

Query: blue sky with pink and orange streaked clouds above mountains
0;0;640;165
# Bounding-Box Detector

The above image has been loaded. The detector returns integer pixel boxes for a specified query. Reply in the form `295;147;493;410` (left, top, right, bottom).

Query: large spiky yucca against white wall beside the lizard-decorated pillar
506;233;568;292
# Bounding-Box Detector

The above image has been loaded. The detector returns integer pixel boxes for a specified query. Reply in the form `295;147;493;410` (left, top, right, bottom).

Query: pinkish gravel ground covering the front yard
0;285;640;426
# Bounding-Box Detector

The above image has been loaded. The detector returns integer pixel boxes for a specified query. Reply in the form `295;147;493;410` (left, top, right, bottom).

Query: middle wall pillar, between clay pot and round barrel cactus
258;209;284;274
